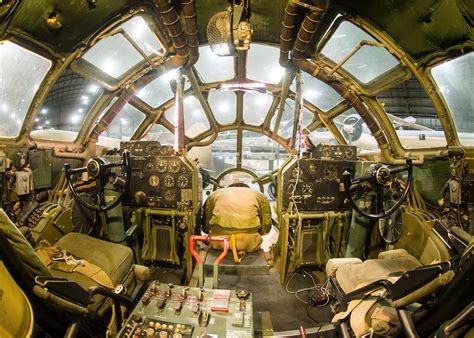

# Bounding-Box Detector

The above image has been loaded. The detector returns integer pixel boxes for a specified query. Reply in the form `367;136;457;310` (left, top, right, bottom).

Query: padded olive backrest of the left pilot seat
0;209;52;276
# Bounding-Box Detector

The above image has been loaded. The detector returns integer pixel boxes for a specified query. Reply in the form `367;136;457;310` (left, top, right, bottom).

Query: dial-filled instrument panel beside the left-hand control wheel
120;141;199;208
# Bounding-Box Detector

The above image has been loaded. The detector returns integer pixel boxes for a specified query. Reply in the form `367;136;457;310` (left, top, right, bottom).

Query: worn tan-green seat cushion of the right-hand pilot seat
336;254;422;293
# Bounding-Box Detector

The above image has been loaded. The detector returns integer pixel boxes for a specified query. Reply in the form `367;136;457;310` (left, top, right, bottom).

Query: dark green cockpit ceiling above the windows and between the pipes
0;0;474;61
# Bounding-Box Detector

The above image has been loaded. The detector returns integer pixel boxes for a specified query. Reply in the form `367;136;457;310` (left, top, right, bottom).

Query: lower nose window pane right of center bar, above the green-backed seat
242;131;288;175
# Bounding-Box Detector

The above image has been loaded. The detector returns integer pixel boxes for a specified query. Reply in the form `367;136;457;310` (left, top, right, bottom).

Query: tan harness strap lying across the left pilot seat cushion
35;241;114;289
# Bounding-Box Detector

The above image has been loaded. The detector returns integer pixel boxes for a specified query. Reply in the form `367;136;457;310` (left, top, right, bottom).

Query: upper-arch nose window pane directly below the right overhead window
291;72;343;111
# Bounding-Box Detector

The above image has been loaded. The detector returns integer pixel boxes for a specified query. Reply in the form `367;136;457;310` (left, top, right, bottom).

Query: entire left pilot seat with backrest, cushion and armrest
0;210;146;334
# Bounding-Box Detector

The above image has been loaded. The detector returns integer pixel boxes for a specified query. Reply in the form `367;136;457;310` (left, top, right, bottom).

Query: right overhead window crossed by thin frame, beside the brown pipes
321;21;398;84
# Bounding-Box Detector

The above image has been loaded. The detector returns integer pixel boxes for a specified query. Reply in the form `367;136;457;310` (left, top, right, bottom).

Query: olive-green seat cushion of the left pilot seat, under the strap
52;232;133;289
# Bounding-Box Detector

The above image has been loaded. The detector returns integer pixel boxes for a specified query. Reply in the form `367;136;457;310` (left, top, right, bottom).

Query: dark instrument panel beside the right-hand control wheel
281;144;357;211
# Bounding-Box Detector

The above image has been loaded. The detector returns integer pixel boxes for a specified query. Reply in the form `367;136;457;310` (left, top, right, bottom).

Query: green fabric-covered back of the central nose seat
204;187;272;235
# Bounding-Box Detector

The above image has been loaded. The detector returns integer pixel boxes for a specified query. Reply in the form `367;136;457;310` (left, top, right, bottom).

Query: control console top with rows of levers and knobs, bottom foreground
118;281;254;338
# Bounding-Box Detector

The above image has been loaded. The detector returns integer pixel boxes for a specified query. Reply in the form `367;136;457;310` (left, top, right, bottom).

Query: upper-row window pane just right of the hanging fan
247;43;285;83
